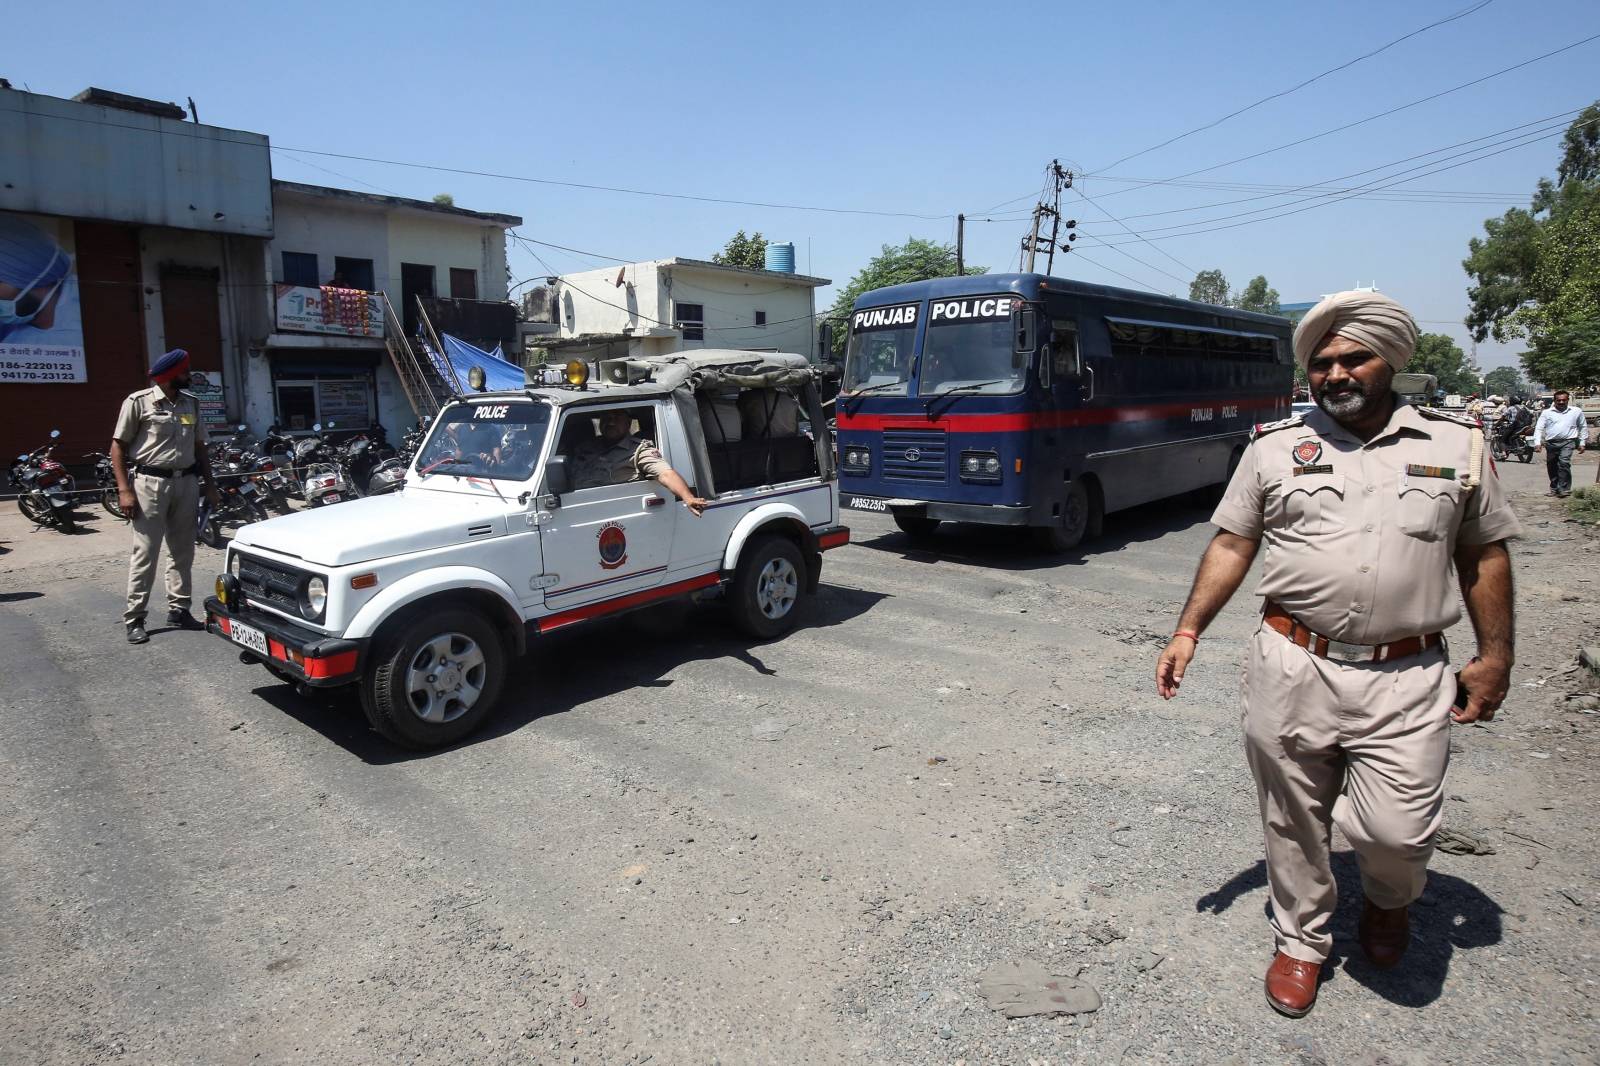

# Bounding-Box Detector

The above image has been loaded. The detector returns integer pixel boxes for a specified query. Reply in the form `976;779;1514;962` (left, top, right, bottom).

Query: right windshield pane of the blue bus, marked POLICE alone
917;295;1027;395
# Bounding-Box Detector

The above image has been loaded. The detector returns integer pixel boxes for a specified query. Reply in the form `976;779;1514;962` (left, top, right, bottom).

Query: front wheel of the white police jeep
362;608;506;749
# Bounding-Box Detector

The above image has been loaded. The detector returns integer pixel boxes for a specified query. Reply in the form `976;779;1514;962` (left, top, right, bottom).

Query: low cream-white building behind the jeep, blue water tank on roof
522;258;832;359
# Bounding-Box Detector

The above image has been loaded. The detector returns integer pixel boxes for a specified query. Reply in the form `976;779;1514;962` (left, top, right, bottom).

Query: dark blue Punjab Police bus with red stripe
837;274;1294;552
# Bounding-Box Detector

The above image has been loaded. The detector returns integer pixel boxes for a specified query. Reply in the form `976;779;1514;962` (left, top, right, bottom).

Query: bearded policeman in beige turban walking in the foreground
1155;293;1522;1018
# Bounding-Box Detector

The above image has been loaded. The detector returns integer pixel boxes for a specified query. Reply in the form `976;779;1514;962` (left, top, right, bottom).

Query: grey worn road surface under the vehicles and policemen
0;466;1600;1063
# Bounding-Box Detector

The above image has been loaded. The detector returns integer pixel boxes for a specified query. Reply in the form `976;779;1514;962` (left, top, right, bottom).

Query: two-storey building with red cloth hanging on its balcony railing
259;181;522;437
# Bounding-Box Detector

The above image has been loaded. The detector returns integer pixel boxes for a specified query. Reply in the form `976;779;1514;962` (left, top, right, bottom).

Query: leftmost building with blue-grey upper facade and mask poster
0;88;272;463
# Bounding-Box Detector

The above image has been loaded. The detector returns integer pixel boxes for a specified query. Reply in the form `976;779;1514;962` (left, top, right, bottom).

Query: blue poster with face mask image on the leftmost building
0;211;88;384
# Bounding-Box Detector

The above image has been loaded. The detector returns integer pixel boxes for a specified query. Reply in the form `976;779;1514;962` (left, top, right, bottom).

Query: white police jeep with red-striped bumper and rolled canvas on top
205;351;850;747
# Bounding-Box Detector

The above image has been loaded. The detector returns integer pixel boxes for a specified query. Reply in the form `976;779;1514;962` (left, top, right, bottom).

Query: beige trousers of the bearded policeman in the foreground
1243;626;1456;962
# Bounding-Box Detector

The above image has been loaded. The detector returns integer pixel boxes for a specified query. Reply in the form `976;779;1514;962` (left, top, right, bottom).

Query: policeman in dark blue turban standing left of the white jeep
110;349;218;643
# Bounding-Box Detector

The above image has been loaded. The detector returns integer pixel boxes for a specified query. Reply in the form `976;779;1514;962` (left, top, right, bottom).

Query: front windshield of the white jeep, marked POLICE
416;400;550;482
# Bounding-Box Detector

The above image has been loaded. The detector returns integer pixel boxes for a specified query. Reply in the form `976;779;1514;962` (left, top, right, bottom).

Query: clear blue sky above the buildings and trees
12;0;1600;367
